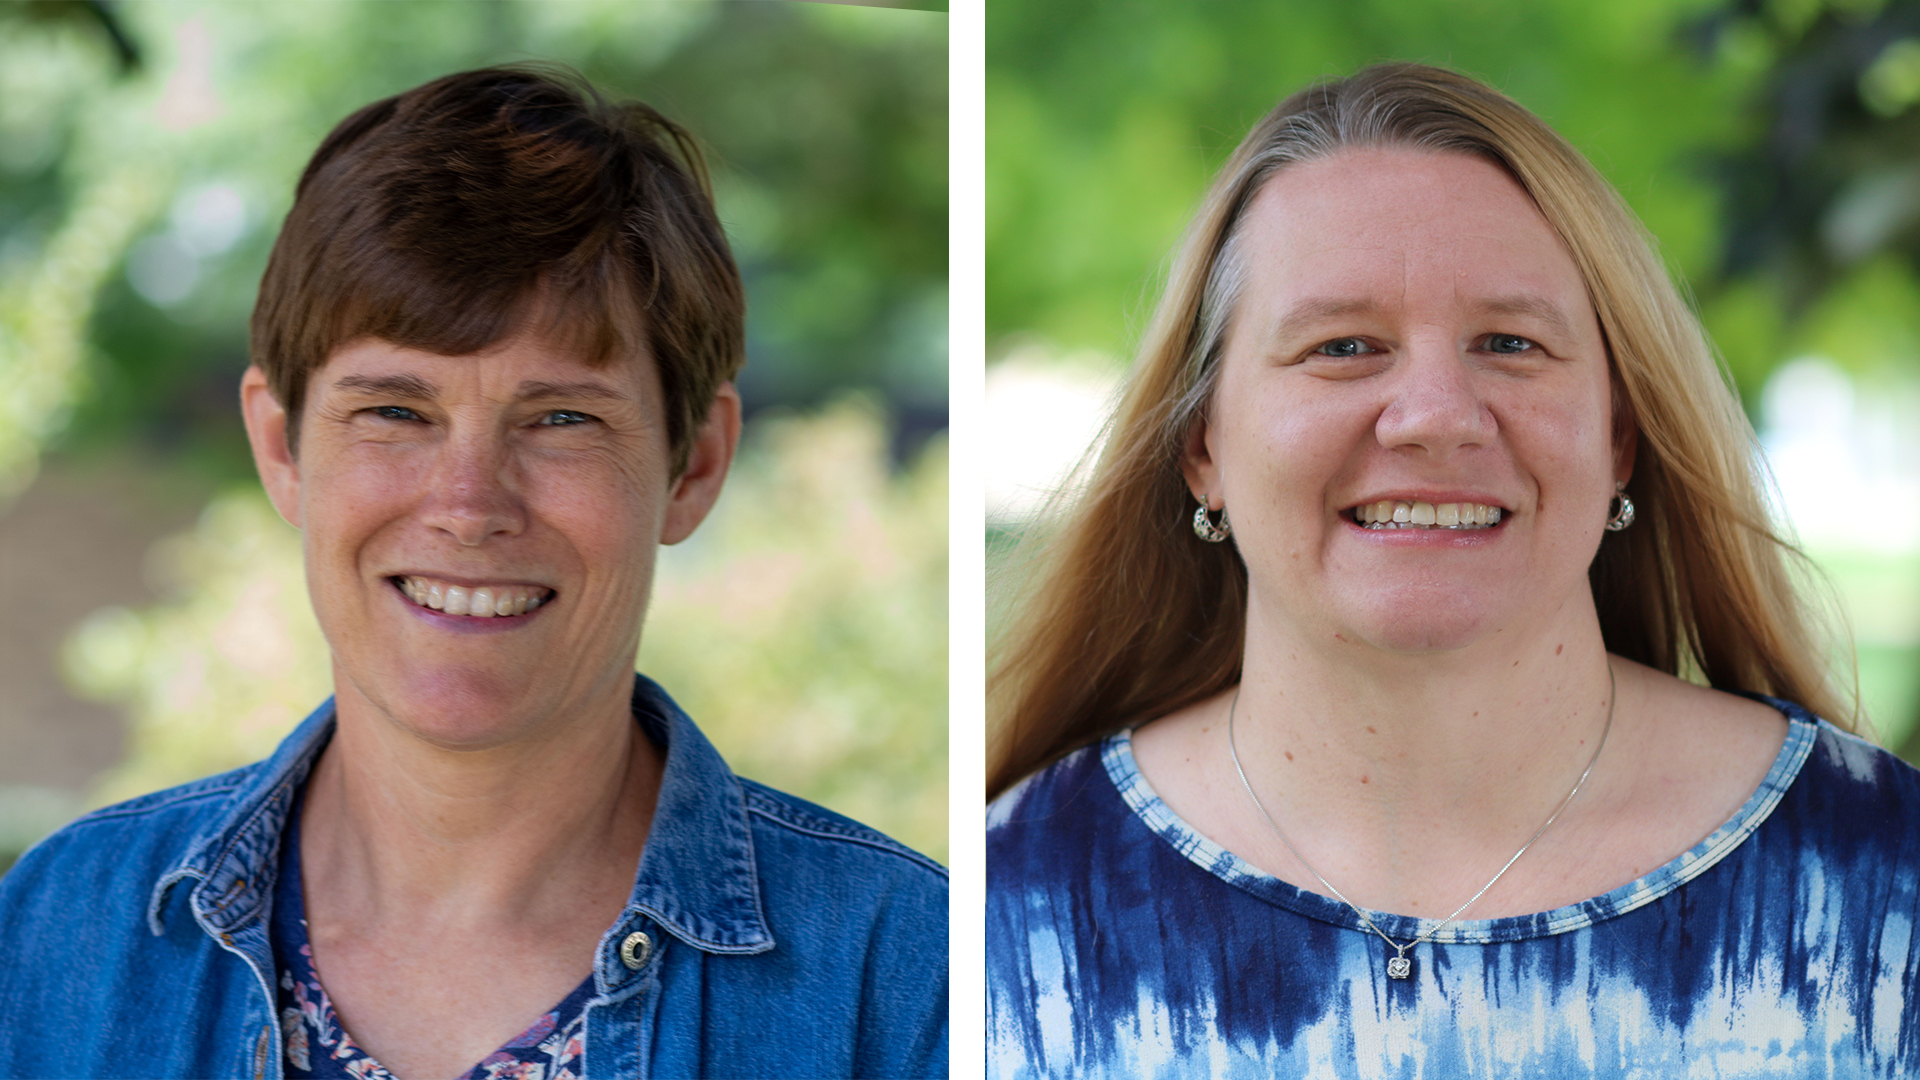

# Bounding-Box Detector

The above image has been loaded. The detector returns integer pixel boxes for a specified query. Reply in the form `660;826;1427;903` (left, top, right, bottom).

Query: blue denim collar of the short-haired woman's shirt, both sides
148;675;774;953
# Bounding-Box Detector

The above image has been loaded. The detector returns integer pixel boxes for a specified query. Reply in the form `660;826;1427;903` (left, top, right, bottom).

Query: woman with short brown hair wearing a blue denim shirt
0;67;947;1080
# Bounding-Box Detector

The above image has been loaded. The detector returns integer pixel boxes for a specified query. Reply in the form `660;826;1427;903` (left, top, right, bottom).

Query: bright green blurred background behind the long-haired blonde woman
985;0;1920;761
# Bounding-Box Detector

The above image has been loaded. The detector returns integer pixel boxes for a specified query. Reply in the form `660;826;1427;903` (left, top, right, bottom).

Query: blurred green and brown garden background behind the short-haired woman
0;0;947;867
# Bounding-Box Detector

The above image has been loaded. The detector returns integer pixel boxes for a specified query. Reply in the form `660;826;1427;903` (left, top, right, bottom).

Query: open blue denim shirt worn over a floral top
0;676;947;1078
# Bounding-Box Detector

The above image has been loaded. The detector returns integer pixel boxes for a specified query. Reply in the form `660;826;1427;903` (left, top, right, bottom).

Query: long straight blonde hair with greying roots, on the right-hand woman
987;63;1853;798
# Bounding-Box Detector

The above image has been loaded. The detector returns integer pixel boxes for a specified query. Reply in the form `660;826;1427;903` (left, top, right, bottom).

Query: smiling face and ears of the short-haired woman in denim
242;336;739;748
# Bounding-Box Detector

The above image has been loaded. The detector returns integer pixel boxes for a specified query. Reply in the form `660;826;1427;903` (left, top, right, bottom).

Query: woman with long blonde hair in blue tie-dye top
987;65;1920;1076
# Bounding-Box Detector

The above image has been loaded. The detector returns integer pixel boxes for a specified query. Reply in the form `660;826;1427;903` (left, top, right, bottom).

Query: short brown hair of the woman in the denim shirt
252;67;747;475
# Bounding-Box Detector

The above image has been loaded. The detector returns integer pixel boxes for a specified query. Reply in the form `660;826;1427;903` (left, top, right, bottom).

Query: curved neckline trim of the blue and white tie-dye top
1100;696;1824;945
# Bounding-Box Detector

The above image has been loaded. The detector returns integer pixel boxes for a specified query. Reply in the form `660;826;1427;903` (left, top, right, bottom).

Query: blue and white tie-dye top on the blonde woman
987;700;1920;1078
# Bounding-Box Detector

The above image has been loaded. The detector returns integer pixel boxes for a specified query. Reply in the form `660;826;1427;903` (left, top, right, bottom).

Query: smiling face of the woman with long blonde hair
1183;150;1632;651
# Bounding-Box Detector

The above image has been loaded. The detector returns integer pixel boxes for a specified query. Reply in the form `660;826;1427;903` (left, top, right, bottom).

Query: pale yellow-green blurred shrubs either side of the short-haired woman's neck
61;398;947;859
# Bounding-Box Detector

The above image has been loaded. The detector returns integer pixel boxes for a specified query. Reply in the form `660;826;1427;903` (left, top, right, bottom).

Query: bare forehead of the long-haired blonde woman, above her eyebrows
1242;148;1592;315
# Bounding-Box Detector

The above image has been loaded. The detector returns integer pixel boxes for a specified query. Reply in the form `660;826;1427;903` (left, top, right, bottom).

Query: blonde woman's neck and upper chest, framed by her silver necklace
1221;592;1613;917
